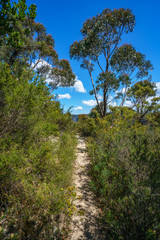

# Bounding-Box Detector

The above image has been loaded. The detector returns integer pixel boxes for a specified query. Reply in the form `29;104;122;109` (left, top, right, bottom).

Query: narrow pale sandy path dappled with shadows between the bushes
69;136;104;240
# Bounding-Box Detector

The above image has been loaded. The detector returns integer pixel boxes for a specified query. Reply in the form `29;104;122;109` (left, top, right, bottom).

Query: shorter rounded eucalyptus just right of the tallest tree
110;44;153;106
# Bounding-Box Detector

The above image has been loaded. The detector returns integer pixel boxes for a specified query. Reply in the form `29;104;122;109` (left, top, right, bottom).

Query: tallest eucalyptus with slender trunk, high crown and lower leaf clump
70;8;135;117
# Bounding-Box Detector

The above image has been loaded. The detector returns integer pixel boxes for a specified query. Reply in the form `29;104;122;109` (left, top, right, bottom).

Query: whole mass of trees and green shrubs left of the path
0;0;76;240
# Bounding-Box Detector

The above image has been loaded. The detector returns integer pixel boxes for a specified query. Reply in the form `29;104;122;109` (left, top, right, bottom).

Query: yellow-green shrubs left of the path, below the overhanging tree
0;60;76;239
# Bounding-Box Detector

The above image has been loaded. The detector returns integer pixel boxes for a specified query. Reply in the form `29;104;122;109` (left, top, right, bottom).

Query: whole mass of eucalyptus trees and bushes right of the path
74;8;160;240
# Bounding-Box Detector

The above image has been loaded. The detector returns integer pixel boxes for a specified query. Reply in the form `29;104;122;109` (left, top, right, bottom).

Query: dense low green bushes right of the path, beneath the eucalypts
77;102;160;240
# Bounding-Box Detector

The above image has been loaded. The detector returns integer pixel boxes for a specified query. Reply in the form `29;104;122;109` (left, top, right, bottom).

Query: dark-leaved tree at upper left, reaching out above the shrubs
0;0;75;88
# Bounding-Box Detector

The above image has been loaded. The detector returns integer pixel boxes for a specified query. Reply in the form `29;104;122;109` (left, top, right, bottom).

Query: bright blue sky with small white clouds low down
27;0;160;114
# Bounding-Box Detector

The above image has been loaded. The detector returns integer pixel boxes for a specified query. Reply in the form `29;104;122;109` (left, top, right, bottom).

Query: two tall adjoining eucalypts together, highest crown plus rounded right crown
70;8;152;117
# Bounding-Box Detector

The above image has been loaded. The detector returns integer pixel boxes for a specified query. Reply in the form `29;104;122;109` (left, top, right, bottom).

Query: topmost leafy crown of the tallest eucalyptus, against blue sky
70;9;135;60
